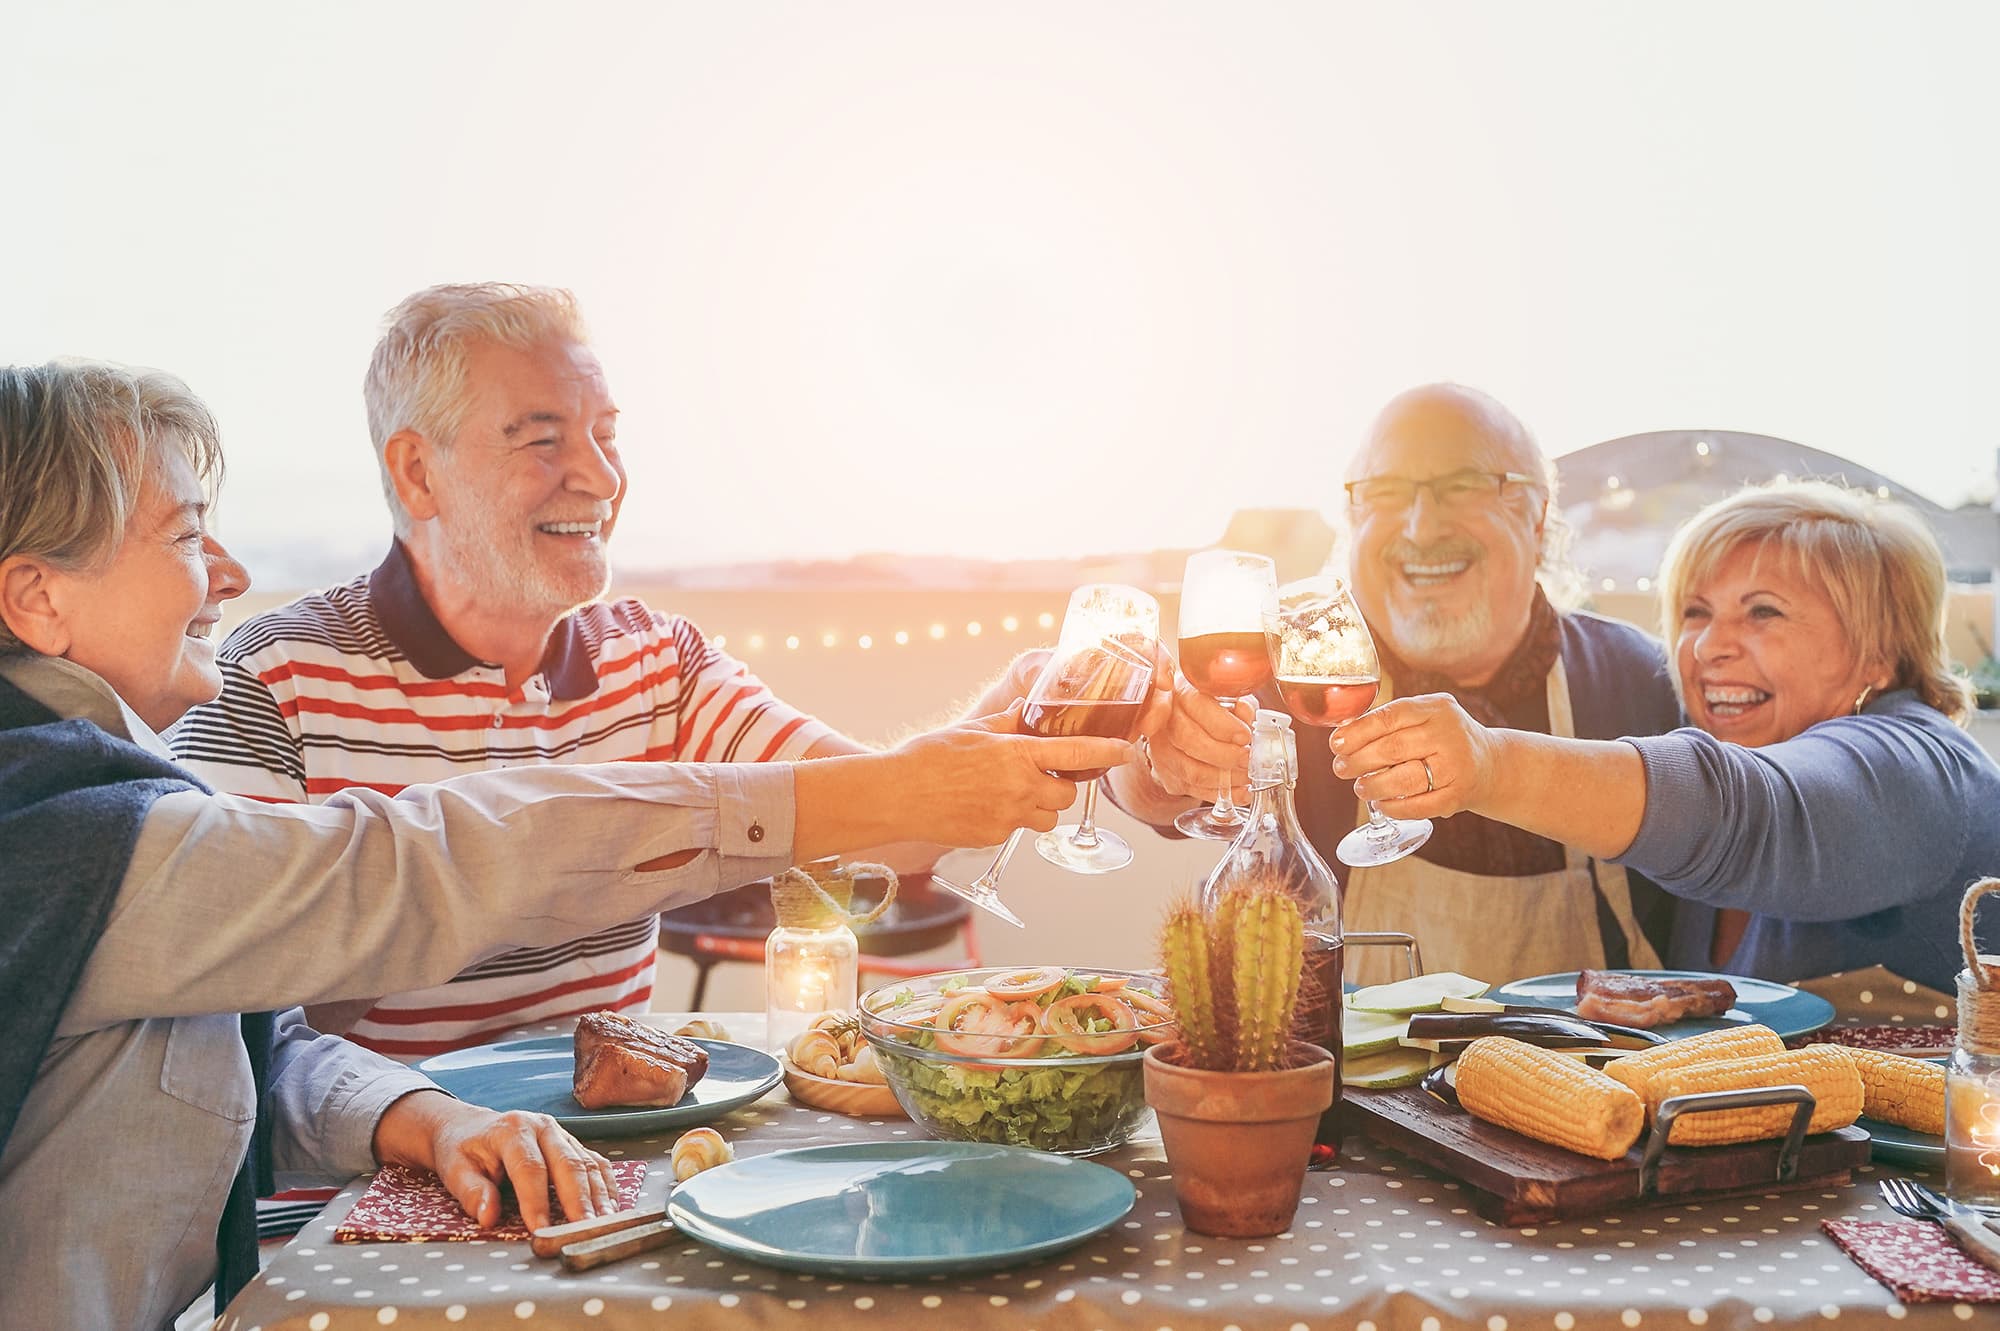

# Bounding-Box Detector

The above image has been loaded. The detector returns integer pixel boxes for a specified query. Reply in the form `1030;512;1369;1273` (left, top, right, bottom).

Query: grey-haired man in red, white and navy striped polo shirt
170;286;1006;1061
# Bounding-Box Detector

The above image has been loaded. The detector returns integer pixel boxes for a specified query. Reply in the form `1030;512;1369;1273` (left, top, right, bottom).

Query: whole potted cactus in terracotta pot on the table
1146;877;1334;1239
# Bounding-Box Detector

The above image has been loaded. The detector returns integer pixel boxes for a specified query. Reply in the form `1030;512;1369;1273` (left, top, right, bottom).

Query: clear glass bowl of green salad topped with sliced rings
862;965;1178;1155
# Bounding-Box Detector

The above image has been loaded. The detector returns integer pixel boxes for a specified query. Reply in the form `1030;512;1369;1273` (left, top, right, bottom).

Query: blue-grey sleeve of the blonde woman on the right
1620;691;1996;921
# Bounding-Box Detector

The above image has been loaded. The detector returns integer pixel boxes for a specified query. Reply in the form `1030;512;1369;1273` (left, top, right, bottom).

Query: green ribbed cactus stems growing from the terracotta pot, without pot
1160;873;1306;1071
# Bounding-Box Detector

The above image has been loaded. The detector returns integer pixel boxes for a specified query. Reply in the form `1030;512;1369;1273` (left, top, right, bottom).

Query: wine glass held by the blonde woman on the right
1268;574;1430;867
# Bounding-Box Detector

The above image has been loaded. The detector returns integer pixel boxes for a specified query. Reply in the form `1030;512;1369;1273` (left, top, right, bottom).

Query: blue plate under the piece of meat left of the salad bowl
416;1035;782;1137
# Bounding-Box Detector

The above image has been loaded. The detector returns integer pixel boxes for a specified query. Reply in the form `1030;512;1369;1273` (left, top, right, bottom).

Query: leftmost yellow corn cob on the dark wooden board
1456;1035;1646;1159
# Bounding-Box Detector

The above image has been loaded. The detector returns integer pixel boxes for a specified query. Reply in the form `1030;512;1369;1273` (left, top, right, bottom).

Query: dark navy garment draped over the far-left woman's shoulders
0;679;272;1313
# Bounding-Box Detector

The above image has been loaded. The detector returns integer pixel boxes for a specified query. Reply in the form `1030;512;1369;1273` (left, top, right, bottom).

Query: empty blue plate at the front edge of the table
668;1141;1138;1279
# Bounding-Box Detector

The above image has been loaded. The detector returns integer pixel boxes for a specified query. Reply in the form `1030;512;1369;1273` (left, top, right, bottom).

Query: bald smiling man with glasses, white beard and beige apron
1114;384;1680;981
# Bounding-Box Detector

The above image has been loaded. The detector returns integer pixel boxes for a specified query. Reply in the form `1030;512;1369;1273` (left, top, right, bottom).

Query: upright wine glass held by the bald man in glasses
1174;550;1278;841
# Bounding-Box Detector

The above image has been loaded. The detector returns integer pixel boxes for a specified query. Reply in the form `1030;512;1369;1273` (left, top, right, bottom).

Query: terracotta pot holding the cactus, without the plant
1146;1043;1334;1239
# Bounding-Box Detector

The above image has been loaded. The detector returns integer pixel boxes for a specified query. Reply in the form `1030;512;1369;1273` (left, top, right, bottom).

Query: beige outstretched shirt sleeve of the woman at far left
60;763;794;1035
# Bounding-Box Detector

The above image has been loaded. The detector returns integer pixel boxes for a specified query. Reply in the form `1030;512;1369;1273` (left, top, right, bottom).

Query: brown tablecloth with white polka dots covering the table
222;999;1996;1331
